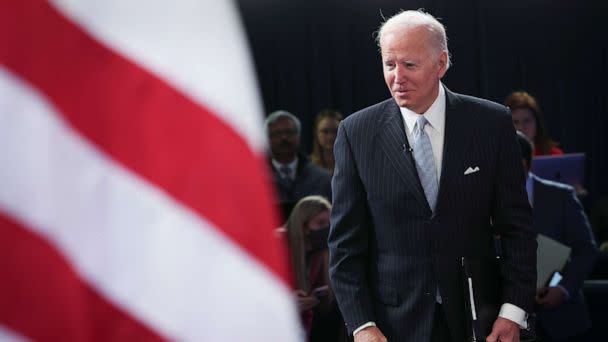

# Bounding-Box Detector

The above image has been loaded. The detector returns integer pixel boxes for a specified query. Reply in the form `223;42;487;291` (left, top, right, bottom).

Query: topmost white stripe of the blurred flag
51;0;266;152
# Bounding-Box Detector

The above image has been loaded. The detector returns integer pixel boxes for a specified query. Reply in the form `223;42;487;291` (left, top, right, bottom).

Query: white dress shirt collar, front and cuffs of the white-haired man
353;83;528;336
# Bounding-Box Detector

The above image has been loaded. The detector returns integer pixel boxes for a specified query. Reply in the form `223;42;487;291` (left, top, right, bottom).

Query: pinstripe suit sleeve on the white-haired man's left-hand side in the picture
328;124;374;334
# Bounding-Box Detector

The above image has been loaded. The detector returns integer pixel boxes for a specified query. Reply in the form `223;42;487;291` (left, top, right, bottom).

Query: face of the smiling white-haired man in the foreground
380;27;448;114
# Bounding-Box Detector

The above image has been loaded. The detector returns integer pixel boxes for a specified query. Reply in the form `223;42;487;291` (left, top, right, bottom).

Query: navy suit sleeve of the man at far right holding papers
560;189;597;295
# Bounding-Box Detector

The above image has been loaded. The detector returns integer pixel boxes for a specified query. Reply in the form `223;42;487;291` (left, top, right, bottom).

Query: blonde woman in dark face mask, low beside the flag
285;196;346;341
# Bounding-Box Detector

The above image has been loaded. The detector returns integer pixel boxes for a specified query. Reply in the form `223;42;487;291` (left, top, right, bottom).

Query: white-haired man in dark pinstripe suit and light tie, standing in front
329;11;536;342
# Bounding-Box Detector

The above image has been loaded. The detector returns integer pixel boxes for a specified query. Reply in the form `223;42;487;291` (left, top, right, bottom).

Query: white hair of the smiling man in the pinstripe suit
376;9;452;70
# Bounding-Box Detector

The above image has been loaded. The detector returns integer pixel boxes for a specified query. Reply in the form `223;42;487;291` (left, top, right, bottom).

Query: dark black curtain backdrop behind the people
238;0;608;206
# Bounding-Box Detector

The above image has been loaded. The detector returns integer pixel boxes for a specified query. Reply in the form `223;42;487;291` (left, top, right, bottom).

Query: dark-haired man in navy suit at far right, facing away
517;132;597;342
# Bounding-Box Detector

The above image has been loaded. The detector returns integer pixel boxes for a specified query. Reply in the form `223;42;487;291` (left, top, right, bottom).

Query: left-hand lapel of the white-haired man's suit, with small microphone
378;101;430;210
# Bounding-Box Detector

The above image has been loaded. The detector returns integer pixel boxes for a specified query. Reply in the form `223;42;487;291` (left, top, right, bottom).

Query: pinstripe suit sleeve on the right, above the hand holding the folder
492;108;537;313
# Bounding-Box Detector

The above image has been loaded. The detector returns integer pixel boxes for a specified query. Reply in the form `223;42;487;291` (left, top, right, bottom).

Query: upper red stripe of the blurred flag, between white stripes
0;0;289;280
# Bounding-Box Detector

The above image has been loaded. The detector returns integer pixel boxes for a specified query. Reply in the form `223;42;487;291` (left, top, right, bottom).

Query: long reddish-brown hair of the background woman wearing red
505;91;558;154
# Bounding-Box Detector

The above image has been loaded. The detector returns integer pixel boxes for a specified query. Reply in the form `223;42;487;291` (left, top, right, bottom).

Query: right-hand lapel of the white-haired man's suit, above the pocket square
435;87;473;212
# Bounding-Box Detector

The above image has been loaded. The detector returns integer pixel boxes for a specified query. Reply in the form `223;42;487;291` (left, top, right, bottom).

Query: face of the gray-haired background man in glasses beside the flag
268;117;300;159
